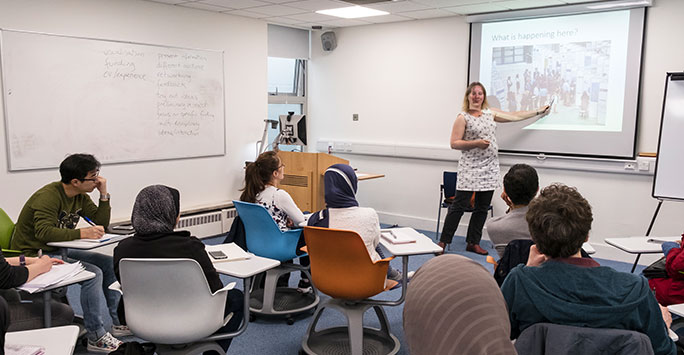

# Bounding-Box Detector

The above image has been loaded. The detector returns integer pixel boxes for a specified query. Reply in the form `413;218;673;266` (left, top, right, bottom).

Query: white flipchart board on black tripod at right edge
653;73;684;200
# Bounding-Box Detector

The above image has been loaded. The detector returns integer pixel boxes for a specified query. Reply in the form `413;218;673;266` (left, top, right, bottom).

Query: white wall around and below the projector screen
309;0;684;263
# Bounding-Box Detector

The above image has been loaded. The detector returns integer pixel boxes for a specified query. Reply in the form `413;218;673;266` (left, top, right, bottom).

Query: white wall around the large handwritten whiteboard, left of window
0;0;267;220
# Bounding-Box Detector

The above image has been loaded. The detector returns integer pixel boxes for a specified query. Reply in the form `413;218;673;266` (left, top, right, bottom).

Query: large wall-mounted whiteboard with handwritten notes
0;30;226;170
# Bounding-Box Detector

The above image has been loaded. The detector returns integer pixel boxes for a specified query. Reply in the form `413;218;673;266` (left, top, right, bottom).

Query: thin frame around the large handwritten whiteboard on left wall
0;27;227;171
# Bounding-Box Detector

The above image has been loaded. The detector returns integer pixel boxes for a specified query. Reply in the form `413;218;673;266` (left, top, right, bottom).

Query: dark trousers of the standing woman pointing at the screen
439;190;494;244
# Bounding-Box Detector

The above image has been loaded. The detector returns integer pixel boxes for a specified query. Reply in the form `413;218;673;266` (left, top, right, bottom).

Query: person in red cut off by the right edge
648;235;684;306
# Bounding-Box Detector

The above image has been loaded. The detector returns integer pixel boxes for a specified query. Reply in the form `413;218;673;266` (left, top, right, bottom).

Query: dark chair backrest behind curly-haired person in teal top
515;323;653;355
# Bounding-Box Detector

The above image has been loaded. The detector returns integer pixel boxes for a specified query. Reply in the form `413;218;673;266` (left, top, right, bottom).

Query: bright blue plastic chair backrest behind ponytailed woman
233;201;302;261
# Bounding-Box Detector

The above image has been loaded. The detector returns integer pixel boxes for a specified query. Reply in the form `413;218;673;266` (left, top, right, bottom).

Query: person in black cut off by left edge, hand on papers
0;252;74;349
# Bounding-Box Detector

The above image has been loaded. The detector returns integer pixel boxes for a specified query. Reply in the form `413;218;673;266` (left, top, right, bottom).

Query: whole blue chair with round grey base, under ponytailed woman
233;201;320;324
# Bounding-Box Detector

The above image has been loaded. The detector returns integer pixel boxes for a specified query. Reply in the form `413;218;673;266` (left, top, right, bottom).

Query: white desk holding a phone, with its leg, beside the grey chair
205;244;280;340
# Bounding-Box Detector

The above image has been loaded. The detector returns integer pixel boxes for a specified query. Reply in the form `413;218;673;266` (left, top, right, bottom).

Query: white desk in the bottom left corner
5;325;79;355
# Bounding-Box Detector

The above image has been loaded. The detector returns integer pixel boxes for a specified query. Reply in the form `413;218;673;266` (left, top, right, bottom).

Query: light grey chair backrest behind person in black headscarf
119;258;226;344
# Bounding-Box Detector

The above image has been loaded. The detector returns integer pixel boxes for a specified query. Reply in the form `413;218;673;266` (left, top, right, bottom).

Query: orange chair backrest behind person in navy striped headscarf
304;227;389;300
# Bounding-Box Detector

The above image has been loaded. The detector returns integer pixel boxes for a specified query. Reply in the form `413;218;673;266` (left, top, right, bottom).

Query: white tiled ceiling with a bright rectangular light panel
142;0;600;29
